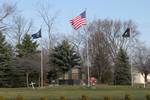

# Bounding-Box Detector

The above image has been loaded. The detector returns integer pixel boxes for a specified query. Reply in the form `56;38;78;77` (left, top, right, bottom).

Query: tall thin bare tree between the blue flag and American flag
38;2;57;83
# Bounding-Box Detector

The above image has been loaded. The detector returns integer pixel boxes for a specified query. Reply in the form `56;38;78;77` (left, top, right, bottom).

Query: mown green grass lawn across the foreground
0;86;150;100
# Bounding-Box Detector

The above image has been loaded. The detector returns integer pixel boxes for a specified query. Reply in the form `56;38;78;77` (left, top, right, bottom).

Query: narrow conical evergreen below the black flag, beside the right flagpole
114;48;131;85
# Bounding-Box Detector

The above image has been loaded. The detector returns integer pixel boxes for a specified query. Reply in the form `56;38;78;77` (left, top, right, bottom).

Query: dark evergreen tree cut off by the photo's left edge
0;32;13;87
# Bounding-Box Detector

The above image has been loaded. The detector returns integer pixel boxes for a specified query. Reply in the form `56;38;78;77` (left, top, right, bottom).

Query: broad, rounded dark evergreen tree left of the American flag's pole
50;40;81;79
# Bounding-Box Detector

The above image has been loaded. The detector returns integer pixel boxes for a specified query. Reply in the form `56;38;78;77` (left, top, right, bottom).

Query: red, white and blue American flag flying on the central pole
70;11;86;30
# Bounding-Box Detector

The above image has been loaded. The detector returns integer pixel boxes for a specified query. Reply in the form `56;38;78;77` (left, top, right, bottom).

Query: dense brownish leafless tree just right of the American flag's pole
89;32;112;83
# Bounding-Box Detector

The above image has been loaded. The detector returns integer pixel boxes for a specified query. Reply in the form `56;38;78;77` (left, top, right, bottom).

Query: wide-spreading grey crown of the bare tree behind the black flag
87;19;139;62
